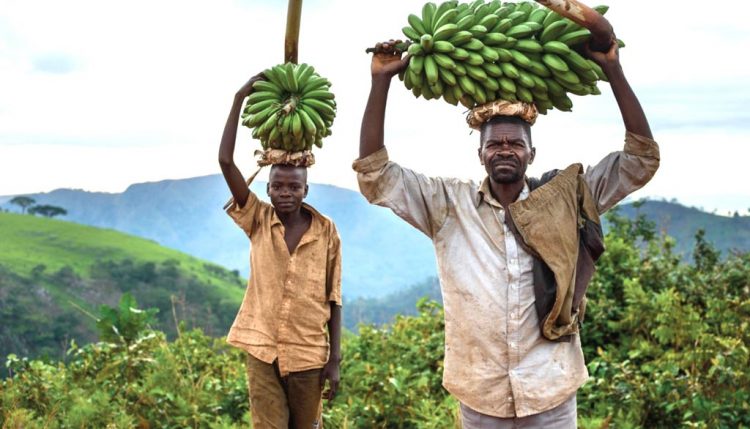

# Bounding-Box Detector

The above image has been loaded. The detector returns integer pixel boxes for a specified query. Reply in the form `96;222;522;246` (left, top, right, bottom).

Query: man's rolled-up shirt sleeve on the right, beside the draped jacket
584;132;660;214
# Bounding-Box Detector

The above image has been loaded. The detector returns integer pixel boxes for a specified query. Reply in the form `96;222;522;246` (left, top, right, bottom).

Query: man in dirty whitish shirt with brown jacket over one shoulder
353;38;659;428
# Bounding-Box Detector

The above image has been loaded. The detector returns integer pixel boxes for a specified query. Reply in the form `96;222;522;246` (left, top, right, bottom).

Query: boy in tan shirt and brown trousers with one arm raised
219;75;341;429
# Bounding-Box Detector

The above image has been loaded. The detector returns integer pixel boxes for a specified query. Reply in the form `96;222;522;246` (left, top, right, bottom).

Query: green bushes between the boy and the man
325;300;457;428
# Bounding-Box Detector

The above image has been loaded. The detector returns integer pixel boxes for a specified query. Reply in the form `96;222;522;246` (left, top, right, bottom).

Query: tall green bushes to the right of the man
578;212;750;428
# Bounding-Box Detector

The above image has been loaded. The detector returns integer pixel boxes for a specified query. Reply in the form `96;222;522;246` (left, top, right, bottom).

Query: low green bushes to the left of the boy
0;330;249;428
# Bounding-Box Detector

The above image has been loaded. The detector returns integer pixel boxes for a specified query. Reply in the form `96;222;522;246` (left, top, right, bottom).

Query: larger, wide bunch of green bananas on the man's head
399;0;624;114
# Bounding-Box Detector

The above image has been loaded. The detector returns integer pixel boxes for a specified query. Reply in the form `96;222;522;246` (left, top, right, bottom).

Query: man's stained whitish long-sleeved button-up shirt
354;133;659;417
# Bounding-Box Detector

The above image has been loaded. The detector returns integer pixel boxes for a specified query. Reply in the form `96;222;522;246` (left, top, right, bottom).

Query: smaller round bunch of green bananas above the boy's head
242;63;336;152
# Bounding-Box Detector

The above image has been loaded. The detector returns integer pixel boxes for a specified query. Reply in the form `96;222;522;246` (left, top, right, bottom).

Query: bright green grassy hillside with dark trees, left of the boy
0;213;245;366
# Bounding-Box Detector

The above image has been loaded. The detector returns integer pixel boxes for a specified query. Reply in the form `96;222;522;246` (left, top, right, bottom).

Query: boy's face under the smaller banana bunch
266;165;307;213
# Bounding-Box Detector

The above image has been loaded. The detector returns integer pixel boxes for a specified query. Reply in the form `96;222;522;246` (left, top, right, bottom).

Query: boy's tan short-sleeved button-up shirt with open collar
227;184;341;376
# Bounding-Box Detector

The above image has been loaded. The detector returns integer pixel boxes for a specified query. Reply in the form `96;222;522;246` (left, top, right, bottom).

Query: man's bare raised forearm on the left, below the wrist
359;77;391;159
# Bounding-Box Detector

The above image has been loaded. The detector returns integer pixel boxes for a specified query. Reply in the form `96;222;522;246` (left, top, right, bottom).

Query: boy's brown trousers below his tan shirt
247;354;323;429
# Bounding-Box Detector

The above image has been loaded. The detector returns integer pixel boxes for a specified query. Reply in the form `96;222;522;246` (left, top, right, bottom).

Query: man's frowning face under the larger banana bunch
479;122;536;184
